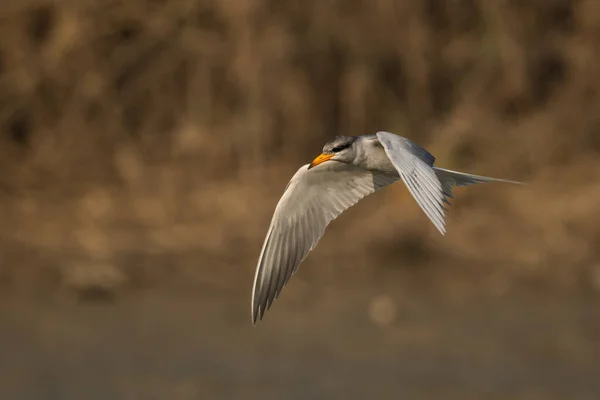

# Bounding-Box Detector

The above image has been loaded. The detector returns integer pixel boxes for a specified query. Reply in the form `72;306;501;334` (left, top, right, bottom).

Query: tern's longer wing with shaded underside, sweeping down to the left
252;161;398;323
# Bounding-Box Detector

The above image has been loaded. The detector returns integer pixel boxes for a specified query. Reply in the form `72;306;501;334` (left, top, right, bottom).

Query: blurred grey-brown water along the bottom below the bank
0;291;600;400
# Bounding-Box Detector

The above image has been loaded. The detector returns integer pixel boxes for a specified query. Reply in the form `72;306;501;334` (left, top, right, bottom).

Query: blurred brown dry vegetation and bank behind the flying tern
0;0;600;296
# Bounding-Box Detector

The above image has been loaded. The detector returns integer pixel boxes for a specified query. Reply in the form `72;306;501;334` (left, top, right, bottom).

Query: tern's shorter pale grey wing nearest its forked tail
376;132;446;235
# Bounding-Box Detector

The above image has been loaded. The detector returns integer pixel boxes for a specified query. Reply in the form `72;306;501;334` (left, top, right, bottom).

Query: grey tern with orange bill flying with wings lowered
252;132;522;324
